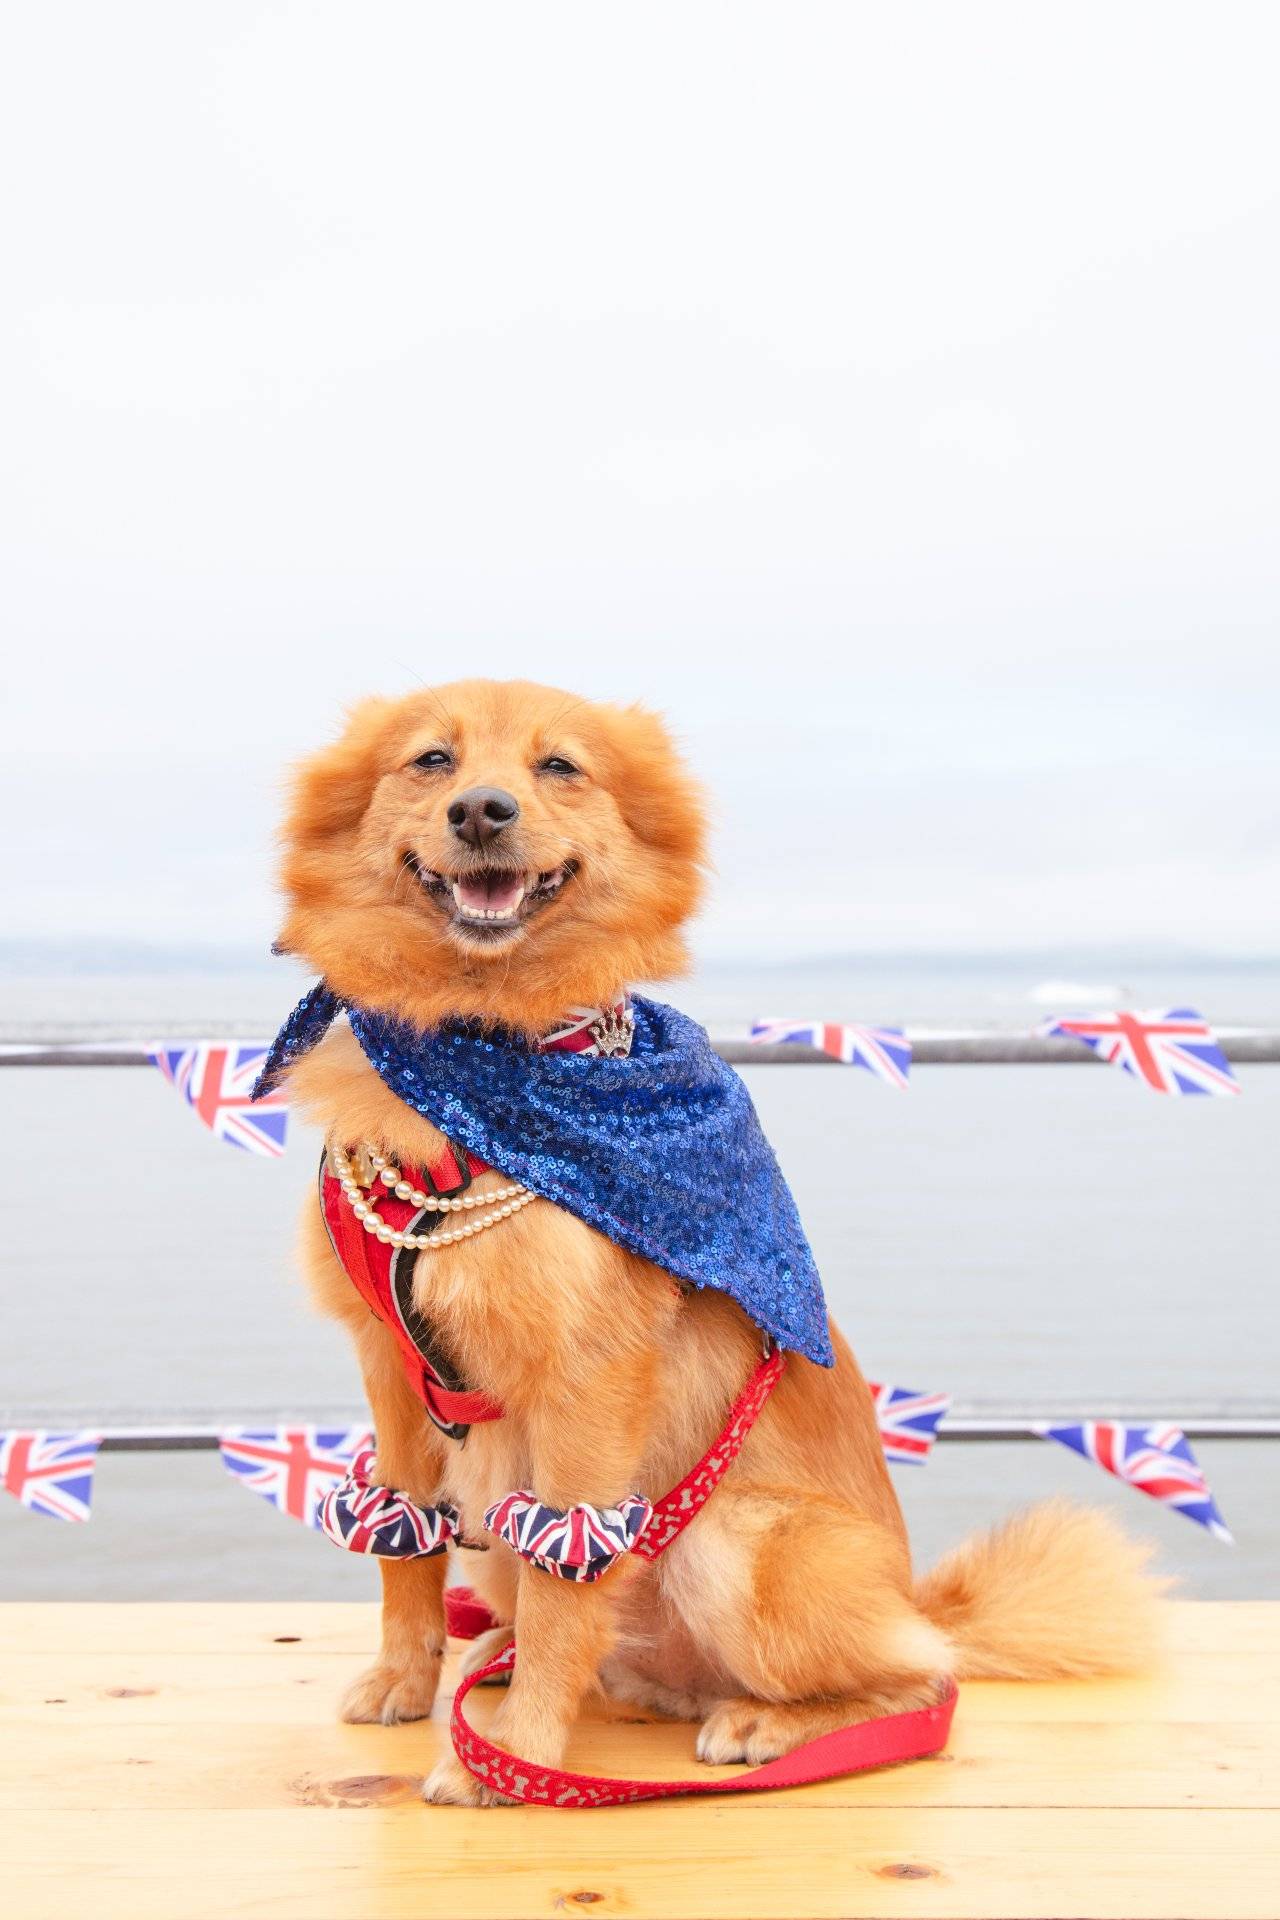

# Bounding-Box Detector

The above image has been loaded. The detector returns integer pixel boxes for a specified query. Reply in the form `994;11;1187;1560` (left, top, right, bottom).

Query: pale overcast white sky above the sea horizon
0;0;1280;954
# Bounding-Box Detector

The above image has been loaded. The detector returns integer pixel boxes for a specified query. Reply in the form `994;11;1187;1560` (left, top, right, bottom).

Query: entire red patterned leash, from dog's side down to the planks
445;1350;956;1807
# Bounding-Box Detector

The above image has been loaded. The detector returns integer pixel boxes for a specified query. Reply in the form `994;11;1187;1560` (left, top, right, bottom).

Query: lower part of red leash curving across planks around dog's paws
449;1640;956;1807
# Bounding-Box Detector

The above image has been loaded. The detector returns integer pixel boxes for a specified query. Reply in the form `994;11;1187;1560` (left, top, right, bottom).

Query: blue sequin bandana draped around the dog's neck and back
253;981;835;1367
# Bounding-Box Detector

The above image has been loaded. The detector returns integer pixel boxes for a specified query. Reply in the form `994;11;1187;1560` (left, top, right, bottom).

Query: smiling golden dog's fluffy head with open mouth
280;680;704;1031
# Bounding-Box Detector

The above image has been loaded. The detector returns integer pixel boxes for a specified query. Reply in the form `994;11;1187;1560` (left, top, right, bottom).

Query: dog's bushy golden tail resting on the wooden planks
915;1500;1169;1680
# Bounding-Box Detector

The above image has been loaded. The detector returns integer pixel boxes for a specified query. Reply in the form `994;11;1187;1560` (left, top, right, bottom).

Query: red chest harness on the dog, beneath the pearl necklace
320;1148;503;1440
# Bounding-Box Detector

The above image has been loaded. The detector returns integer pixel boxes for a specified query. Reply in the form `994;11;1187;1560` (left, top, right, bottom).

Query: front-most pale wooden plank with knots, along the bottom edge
6;1812;1280;1920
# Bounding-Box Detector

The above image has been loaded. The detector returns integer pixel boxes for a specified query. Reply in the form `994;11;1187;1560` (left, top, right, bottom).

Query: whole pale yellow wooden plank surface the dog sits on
0;1603;1280;1920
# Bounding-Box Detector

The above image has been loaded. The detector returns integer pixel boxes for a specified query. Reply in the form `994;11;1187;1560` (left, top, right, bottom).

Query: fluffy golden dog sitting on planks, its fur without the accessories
282;680;1157;1805
